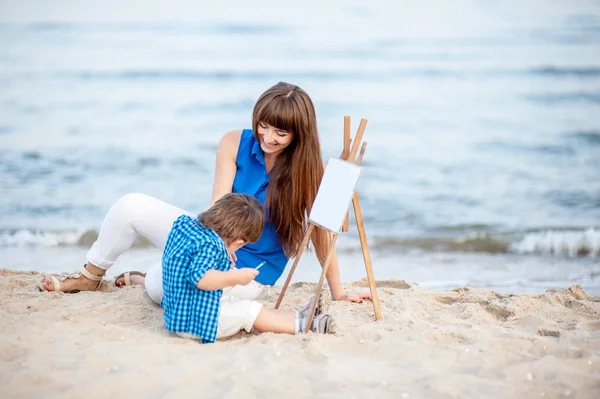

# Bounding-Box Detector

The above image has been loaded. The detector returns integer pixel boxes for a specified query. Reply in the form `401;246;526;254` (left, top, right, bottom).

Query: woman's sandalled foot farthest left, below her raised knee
39;263;106;293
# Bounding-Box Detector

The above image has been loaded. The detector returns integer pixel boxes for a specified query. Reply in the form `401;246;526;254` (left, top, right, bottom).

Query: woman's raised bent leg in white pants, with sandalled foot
43;194;194;292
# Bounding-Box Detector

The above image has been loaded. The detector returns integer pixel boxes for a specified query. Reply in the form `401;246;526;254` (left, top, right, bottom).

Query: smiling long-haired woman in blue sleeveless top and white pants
40;82;371;303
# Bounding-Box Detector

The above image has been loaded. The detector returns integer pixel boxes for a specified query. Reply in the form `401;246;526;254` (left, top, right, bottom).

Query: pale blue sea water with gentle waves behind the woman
0;0;600;293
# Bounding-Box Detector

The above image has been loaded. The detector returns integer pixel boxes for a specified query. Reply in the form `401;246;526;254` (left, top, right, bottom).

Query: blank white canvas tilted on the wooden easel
309;158;362;233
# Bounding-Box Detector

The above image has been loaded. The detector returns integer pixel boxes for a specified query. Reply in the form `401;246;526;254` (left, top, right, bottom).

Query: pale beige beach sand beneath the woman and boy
0;269;600;398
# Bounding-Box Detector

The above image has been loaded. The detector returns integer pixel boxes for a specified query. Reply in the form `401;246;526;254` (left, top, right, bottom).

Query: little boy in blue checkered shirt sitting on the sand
161;194;333;343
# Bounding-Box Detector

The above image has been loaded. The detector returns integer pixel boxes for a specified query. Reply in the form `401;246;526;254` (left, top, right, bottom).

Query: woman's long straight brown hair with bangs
252;82;328;264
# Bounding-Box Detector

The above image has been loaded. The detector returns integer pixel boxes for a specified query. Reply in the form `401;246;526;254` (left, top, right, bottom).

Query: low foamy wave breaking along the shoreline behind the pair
0;228;600;257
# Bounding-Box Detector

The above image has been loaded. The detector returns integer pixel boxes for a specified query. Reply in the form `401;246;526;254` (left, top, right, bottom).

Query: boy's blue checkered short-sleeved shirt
161;215;231;343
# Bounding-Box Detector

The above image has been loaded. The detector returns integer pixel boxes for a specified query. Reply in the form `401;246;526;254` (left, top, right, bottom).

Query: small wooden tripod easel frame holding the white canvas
275;116;381;333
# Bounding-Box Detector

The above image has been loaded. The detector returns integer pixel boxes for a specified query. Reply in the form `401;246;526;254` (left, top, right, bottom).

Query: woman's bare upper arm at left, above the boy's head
210;130;242;205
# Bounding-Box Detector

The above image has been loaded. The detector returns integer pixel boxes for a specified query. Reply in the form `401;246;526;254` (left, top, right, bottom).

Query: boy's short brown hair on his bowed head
198;193;265;245
